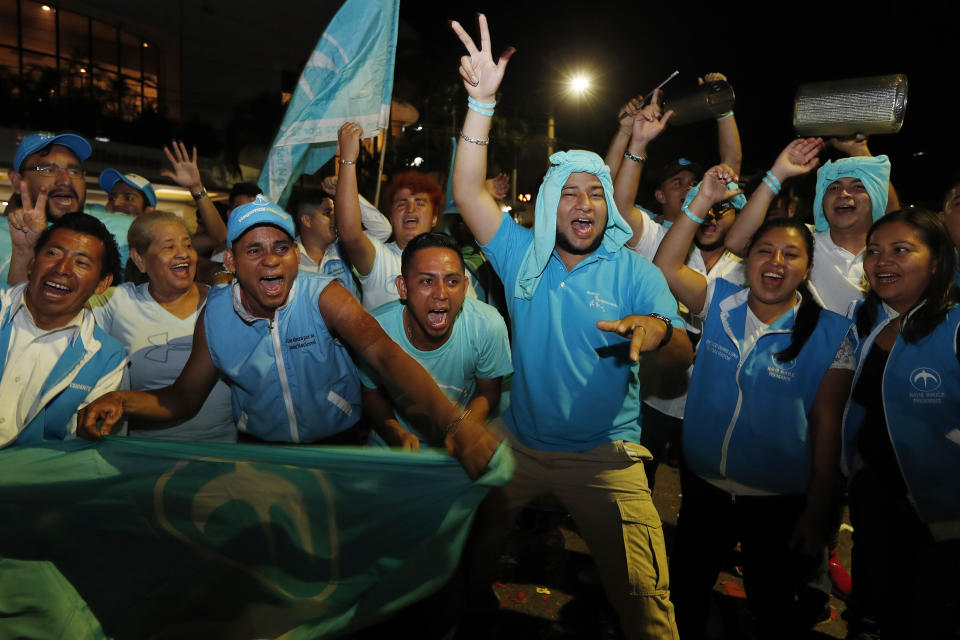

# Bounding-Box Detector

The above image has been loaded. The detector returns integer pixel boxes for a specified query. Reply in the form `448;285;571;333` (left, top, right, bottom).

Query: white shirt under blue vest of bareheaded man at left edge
0;286;126;447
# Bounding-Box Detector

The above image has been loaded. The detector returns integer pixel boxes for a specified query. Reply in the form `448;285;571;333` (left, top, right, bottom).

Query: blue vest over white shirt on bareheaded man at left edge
0;298;127;445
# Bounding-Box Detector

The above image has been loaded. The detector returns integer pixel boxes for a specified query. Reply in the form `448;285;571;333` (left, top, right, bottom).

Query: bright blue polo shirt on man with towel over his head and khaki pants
483;214;685;451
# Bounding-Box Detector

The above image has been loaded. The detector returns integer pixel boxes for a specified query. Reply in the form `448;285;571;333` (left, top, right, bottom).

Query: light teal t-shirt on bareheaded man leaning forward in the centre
360;298;513;446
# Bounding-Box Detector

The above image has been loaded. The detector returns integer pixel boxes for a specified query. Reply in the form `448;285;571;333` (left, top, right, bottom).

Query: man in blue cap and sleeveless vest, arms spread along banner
77;196;497;477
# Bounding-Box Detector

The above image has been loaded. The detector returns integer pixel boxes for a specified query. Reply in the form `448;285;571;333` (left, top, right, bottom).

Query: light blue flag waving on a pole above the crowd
258;0;400;206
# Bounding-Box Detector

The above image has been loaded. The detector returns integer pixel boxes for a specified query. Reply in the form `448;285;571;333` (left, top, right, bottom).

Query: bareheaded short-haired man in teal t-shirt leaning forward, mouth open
361;232;513;450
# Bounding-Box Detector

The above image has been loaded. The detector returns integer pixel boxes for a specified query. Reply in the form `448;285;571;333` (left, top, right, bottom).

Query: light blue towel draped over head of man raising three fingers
513;150;633;300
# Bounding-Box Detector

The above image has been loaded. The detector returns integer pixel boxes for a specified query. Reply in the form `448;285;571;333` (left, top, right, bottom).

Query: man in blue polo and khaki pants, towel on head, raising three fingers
452;15;693;638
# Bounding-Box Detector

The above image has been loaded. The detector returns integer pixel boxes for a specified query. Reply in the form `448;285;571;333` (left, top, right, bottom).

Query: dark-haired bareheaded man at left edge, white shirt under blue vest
0;213;127;447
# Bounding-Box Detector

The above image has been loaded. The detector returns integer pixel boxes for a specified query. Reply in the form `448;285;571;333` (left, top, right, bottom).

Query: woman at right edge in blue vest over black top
843;211;960;638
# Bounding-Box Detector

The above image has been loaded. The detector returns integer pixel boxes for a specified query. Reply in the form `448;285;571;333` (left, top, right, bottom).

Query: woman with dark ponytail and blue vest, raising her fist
654;165;854;638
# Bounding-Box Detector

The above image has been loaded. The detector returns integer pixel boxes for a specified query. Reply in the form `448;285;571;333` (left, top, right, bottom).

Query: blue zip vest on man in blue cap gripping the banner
204;273;360;442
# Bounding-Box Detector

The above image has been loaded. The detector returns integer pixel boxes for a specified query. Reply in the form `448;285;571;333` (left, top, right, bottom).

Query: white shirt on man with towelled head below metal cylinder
810;229;866;315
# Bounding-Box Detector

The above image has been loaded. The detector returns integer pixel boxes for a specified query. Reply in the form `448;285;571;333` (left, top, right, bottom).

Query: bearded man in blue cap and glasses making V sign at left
0;133;133;284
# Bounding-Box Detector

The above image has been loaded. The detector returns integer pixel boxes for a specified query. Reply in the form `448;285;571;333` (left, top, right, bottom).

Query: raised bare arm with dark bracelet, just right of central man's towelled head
613;89;673;247
